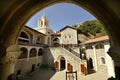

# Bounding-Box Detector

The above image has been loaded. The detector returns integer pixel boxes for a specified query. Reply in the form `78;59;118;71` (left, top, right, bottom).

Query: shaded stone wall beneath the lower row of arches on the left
15;56;42;74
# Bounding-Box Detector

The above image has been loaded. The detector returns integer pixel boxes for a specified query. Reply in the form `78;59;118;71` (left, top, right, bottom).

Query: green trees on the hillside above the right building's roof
73;20;106;36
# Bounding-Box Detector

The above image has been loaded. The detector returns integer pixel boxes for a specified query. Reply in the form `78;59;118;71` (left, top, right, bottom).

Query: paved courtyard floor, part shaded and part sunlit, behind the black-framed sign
20;69;108;80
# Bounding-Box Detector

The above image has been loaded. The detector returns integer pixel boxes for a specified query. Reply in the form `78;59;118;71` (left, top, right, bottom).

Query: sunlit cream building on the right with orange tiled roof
81;36;115;77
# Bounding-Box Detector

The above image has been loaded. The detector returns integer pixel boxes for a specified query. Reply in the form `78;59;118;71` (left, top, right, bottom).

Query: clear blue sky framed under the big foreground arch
26;3;96;31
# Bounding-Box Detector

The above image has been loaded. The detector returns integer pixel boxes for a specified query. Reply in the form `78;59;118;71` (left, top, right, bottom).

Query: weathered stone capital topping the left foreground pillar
0;45;21;64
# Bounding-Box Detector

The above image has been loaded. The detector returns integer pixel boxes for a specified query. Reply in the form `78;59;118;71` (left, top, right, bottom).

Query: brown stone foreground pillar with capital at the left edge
0;45;21;80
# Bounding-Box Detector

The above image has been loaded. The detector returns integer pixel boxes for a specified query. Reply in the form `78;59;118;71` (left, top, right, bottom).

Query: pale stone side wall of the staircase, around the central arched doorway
43;47;82;72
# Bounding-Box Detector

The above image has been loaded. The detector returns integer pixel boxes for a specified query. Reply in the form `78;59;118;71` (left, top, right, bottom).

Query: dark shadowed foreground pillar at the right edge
108;46;120;80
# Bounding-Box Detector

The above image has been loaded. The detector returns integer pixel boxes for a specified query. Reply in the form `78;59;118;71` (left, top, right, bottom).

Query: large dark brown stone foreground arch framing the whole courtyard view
0;0;120;80
